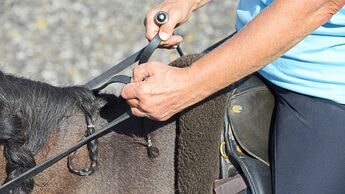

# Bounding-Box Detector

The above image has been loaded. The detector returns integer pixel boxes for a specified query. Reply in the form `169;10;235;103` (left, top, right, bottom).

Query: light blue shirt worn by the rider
236;0;345;104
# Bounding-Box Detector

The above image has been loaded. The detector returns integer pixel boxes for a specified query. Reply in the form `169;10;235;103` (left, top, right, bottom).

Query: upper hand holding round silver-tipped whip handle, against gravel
145;0;198;48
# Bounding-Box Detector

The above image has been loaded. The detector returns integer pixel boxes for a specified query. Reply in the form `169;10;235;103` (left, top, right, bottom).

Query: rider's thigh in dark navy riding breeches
272;87;345;194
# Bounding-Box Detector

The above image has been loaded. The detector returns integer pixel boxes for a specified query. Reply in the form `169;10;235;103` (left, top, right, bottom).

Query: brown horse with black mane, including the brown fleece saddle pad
0;55;230;194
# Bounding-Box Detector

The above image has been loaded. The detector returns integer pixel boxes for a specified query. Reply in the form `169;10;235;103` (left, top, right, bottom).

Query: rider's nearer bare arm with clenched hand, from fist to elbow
122;0;345;120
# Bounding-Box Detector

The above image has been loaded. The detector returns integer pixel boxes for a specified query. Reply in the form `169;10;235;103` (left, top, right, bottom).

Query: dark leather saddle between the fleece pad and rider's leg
216;74;274;194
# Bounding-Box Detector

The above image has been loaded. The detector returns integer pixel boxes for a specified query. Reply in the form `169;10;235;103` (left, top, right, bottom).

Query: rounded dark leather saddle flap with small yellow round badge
228;76;274;165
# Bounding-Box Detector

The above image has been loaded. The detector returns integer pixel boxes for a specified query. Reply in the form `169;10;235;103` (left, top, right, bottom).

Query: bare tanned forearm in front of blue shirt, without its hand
188;0;345;98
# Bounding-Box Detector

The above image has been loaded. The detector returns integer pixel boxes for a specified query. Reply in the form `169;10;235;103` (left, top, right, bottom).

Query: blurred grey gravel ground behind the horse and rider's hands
0;0;236;85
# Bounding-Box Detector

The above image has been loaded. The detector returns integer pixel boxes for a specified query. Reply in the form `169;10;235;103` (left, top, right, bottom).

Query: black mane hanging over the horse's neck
0;72;103;193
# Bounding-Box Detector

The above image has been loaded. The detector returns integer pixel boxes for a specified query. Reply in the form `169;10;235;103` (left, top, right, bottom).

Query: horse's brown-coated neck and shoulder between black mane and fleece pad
28;102;176;193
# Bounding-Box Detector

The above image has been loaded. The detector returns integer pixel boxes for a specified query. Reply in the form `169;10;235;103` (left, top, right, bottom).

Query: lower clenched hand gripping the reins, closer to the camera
121;61;196;121
